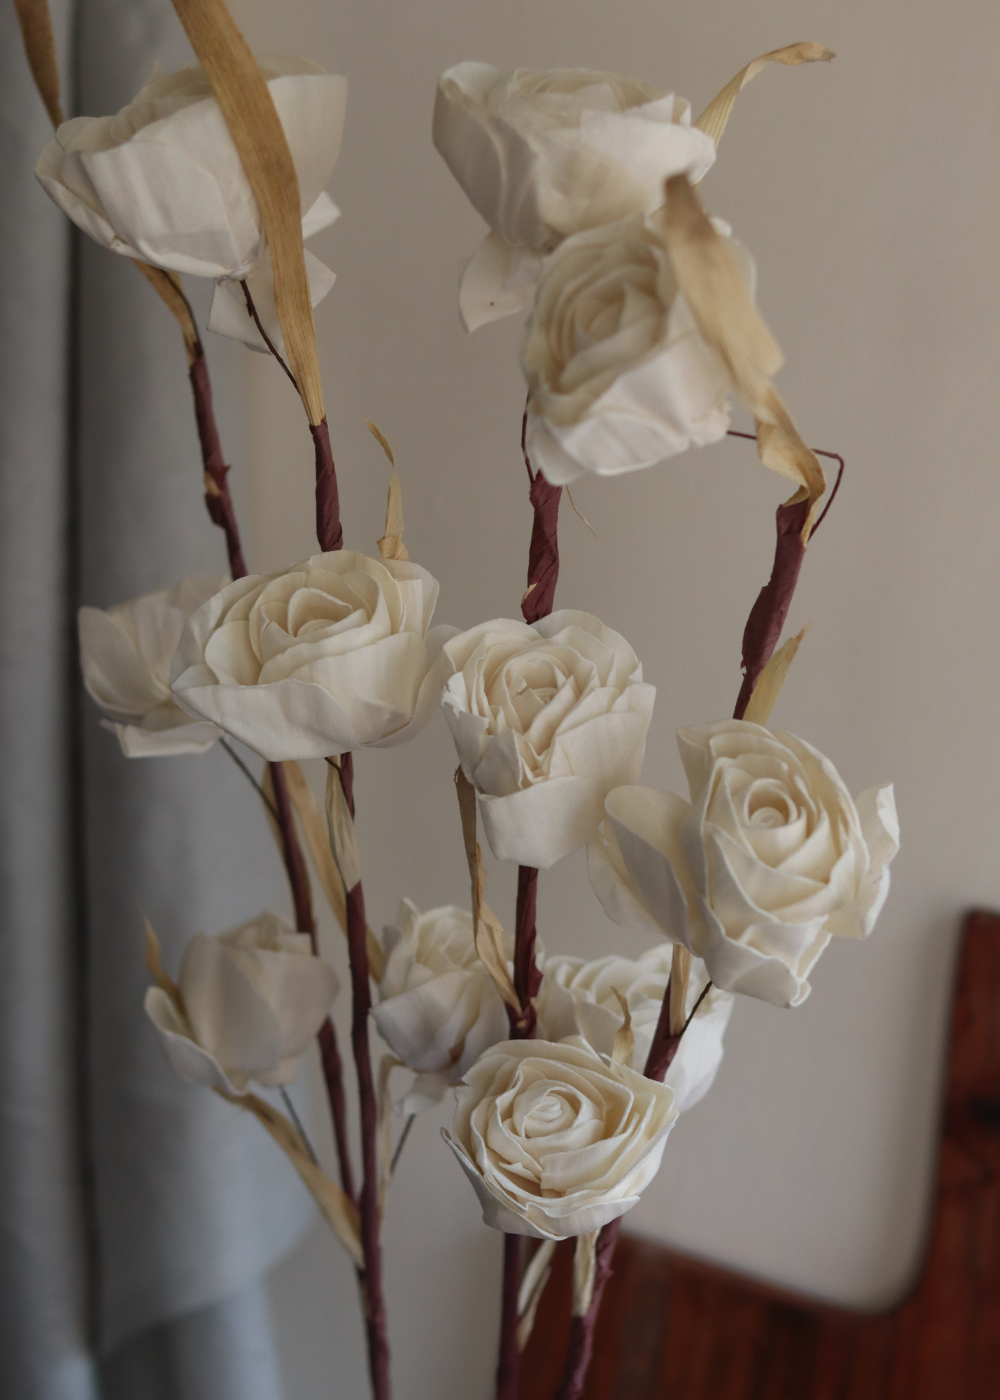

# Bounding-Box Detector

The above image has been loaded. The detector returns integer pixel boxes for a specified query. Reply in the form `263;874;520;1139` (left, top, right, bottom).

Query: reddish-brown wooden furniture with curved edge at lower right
521;910;1000;1400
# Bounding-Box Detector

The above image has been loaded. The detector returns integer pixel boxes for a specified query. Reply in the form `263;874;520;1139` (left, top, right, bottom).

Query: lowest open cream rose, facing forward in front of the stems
444;1040;676;1239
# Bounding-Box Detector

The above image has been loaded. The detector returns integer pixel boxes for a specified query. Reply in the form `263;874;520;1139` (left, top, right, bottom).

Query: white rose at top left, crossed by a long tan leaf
35;57;347;349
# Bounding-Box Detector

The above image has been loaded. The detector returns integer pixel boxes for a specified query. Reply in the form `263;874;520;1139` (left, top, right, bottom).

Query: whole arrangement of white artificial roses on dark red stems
11;0;898;1400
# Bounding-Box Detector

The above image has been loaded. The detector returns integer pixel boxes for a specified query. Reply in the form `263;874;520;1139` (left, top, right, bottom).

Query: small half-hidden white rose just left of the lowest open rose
371;899;508;1112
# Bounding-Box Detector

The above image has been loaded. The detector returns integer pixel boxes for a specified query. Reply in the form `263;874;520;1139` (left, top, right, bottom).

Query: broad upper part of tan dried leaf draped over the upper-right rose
661;175;782;420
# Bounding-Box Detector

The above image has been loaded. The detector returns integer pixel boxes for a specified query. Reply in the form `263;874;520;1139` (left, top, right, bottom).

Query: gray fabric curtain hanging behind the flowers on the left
0;0;312;1400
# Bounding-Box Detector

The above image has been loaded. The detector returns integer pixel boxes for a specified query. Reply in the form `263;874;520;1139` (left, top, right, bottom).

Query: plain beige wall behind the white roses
224;0;1000;1400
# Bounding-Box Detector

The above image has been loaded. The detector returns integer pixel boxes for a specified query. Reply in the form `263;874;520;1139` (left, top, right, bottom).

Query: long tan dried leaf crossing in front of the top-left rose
172;0;324;427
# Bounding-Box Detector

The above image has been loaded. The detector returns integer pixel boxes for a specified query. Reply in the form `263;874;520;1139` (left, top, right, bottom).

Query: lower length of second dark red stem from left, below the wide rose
340;753;389;1400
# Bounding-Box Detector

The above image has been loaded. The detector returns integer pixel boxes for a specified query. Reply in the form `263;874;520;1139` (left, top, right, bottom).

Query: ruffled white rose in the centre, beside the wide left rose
441;609;655;869
